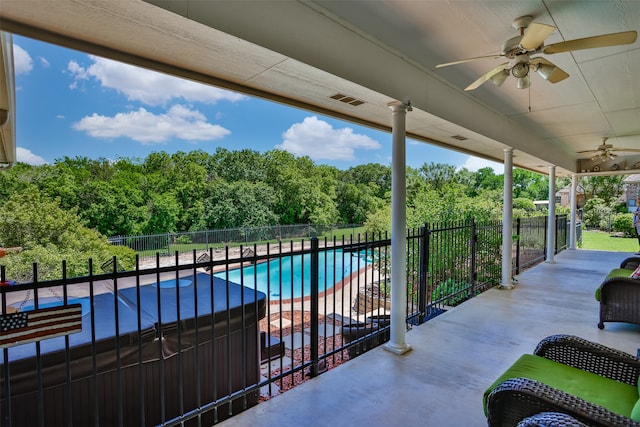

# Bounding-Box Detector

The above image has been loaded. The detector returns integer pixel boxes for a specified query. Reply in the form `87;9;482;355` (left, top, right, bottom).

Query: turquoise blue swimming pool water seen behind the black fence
215;250;371;300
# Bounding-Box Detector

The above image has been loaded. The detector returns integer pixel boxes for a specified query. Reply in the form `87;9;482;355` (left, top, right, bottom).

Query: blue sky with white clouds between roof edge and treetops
8;36;502;173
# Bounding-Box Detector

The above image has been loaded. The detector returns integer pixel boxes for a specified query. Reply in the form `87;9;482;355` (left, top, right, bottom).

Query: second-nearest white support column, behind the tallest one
500;147;513;289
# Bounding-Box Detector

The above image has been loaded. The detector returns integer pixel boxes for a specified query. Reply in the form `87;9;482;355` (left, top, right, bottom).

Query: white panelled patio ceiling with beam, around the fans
0;0;640;176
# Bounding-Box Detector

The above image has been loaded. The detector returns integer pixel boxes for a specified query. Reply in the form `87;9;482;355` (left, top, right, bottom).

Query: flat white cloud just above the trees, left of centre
72;105;231;144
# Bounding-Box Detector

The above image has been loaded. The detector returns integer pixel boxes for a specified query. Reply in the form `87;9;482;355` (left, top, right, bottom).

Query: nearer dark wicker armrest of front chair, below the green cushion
487;378;640;427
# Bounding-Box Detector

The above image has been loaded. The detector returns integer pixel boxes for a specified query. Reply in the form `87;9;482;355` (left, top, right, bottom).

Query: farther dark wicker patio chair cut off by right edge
596;257;640;329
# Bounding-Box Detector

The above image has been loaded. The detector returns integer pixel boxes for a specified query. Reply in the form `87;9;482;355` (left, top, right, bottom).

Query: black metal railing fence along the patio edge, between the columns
0;219;566;426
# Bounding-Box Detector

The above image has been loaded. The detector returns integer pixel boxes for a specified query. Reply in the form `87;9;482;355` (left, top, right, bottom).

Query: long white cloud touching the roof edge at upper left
67;56;246;106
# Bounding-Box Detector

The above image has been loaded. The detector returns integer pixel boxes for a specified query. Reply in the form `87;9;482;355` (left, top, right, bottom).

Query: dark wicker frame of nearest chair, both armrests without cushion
486;335;640;427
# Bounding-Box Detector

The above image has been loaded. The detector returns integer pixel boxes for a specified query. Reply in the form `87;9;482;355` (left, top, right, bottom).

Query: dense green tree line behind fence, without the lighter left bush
0;148;560;236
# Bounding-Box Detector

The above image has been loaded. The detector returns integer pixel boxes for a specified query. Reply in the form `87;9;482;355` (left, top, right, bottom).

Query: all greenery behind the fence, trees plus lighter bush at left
11;148;624;280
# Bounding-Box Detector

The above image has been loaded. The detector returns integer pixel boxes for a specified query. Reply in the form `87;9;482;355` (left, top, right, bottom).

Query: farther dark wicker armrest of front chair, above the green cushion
534;335;640;386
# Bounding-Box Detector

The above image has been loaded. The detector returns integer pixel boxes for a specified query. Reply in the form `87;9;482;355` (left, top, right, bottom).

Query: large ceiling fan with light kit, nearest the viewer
436;16;638;91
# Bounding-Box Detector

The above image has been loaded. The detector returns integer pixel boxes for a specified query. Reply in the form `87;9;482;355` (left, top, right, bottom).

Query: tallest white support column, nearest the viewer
384;102;411;354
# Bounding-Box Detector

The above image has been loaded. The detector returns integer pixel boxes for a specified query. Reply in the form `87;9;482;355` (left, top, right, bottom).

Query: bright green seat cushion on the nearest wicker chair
483;354;638;417
